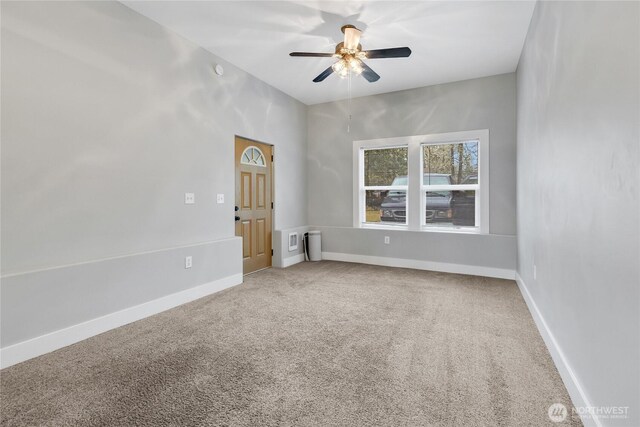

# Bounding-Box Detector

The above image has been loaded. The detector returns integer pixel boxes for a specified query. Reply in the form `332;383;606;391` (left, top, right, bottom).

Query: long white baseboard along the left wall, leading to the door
0;273;242;369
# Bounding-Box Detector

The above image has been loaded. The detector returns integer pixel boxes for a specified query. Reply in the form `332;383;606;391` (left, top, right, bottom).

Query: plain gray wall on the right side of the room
517;2;640;426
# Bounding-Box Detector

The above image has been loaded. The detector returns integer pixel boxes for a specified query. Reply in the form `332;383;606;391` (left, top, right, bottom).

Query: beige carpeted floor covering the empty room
0;261;580;426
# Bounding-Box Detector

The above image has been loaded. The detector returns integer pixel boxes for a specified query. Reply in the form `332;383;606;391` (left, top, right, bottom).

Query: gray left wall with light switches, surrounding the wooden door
1;2;307;346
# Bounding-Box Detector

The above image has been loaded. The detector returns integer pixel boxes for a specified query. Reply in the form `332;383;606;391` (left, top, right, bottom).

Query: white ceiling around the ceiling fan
123;1;535;104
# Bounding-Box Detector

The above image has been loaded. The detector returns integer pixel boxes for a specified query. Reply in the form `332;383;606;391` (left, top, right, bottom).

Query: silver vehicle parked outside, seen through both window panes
380;173;452;223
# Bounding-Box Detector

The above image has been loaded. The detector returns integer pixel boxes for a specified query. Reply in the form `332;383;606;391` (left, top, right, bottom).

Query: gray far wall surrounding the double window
308;74;516;270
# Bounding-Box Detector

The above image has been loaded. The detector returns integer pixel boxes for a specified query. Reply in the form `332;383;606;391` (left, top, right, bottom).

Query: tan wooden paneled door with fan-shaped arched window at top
236;137;273;274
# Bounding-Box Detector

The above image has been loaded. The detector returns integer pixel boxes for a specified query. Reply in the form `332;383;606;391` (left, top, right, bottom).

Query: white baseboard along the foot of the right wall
516;272;602;427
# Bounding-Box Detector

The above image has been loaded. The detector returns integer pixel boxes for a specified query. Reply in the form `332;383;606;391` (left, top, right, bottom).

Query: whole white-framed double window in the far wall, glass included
354;130;489;233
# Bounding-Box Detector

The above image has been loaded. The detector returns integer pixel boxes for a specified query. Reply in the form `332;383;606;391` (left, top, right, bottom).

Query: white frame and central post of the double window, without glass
353;129;490;234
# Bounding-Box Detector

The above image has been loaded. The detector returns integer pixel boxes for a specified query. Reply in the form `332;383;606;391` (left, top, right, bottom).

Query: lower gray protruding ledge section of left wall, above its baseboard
0;237;242;350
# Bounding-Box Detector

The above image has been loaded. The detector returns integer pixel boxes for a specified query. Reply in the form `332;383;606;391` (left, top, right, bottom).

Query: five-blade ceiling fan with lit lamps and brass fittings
289;25;411;83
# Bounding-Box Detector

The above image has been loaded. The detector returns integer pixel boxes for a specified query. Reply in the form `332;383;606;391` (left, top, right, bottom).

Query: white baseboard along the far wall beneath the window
322;252;515;280
